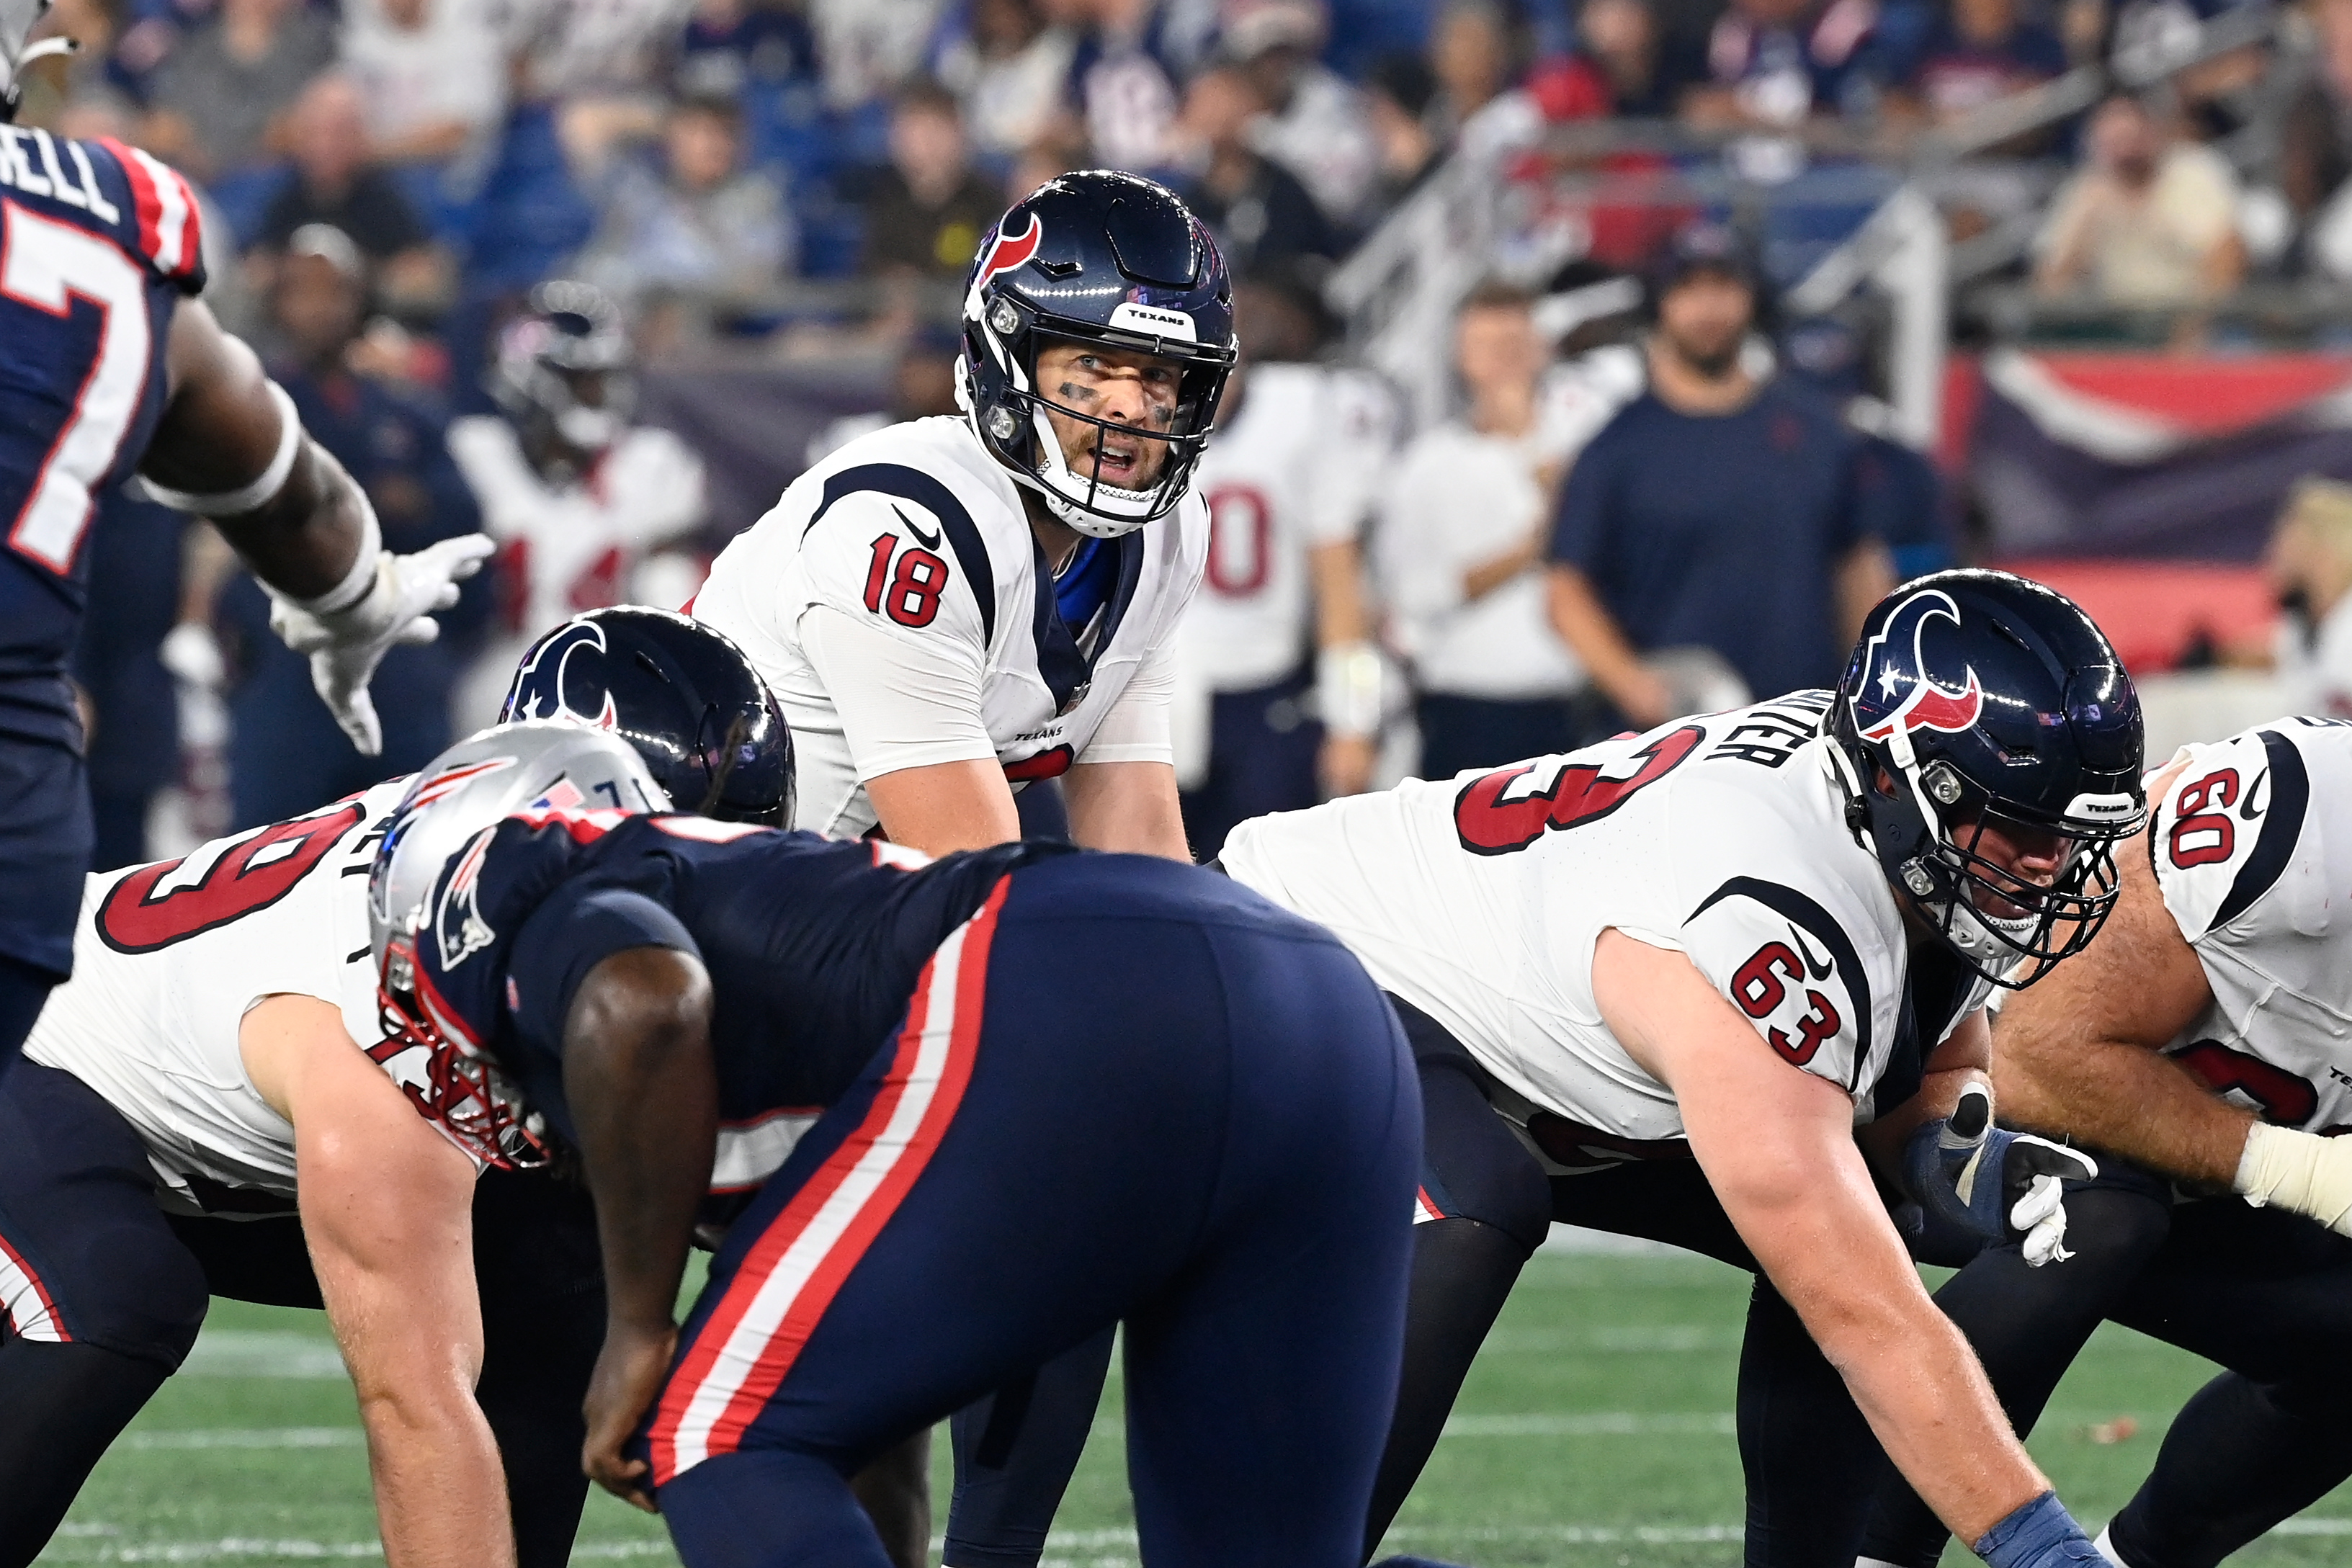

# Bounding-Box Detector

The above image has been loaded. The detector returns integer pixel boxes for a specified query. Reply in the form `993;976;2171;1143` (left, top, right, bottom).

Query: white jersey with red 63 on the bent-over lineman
1221;691;1990;1170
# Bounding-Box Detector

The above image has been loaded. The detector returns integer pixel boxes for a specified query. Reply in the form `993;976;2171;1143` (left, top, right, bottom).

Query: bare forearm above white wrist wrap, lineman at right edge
1992;1030;2255;1187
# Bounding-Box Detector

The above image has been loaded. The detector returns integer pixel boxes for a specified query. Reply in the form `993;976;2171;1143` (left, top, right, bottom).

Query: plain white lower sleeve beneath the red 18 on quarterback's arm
800;604;1001;783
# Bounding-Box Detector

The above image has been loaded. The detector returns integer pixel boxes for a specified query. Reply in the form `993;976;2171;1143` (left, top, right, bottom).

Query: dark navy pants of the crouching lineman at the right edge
1865;1175;2352;1568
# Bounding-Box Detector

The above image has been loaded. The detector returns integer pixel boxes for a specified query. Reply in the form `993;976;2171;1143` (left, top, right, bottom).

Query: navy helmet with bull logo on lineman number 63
1828;571;2147;990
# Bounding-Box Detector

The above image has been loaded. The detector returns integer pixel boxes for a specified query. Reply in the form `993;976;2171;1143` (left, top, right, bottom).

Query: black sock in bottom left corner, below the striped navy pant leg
0;1338;171;1568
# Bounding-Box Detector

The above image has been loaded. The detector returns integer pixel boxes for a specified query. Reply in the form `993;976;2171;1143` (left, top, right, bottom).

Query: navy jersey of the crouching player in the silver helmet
416;811;1073;1190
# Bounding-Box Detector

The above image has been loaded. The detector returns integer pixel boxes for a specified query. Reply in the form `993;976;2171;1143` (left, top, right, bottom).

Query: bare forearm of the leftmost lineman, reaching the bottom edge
360;1380;515;1568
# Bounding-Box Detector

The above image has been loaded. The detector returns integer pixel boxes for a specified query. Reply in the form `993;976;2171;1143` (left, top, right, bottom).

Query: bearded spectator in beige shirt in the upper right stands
2034;94;2246;305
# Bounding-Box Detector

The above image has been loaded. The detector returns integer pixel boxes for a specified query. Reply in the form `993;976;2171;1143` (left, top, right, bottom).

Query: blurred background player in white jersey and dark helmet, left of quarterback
450;279;703;731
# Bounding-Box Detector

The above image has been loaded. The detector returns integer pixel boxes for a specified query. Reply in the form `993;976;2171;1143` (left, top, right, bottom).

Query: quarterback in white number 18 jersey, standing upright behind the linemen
692;169;1237;1563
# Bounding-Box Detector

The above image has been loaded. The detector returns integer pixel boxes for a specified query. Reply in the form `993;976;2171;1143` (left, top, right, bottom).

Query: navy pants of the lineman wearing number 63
1361;999;1877;1568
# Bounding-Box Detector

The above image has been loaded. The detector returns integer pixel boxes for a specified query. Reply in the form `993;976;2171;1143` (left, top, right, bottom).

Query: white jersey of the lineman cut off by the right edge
2150;720;2352;1133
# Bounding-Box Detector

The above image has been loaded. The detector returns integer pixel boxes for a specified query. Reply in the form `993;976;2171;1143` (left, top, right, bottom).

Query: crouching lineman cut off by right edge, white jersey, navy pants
1865;720;2352;1568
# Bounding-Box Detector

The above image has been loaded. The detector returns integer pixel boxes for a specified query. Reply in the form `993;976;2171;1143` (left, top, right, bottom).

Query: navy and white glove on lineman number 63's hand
1902;1084;2098;1267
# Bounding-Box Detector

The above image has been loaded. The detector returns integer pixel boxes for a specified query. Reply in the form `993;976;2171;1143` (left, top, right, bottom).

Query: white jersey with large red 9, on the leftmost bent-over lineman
24;778;444;1213
